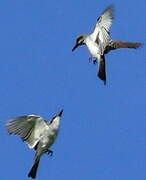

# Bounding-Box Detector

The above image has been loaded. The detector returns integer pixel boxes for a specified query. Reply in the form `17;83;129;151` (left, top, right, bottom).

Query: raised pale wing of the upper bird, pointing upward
92;5;114;55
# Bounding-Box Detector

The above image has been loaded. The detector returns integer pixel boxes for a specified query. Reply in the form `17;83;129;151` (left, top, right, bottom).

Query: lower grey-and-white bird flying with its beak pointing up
6;110;63;179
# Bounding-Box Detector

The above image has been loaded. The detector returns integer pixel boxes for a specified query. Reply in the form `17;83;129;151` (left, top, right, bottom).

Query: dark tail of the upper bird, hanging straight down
98;55;106;84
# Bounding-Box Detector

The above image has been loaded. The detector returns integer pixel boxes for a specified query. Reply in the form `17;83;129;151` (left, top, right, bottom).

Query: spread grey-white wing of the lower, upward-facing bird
6;115;48;148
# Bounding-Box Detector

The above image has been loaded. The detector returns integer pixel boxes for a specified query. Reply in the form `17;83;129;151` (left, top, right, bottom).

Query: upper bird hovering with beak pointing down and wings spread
72;5;142;84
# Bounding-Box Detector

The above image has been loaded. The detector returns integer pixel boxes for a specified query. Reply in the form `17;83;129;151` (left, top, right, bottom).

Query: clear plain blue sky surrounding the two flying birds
0;0;146;180
